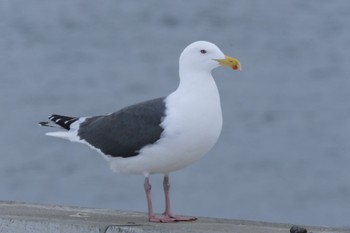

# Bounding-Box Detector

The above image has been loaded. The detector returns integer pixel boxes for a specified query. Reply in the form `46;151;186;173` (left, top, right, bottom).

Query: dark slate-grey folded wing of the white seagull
78;98;165;158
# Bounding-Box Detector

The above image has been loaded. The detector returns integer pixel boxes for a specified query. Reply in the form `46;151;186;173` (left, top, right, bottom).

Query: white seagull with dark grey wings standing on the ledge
39;41;241;223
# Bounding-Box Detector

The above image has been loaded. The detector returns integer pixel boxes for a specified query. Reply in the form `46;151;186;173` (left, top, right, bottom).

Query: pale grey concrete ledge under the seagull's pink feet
0;201;350;233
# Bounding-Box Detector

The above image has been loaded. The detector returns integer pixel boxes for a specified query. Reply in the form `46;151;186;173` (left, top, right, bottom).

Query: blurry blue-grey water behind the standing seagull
0;0;350;227
